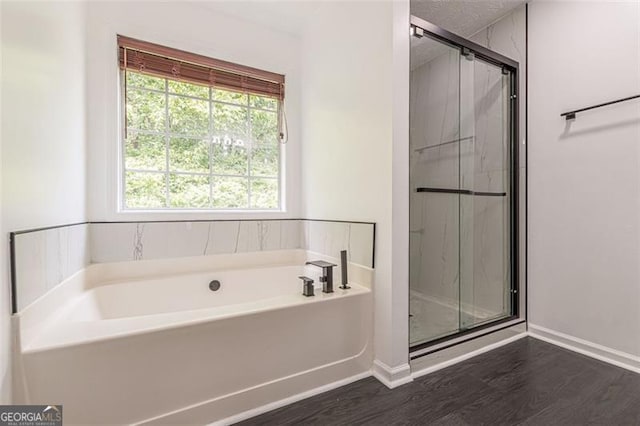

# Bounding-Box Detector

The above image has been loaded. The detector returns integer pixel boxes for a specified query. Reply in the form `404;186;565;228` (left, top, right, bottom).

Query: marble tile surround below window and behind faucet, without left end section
91;219;374;267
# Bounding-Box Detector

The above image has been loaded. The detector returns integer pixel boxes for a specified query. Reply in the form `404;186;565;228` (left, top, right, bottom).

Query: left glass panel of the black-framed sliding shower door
409;37;461;345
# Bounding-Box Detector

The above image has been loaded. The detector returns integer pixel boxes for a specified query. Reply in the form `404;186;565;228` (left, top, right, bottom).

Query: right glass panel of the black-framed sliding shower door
459;49;511;330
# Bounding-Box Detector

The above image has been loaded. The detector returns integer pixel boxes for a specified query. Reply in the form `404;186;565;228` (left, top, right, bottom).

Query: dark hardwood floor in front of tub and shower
240;338;640;426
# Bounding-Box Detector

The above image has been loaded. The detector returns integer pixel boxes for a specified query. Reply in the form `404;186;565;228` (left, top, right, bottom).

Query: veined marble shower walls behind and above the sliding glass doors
410;7;526;321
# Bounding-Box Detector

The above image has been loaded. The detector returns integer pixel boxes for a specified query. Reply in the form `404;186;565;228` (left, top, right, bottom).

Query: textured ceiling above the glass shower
411;0;526;69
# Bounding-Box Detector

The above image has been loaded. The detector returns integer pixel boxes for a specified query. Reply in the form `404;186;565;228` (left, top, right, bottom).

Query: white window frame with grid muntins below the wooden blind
116;41;287;215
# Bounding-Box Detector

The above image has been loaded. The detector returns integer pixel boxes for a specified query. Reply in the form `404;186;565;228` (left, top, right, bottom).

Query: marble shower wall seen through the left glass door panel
409;48;460;310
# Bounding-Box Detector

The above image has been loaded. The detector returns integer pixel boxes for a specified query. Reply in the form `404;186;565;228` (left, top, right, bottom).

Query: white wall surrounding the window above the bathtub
87;1;300;221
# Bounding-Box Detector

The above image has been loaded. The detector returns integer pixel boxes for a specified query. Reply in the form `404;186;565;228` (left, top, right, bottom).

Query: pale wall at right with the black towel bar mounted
529;1;640;356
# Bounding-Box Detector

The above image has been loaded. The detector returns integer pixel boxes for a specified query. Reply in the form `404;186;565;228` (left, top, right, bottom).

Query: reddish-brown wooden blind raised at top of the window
118;35;284;100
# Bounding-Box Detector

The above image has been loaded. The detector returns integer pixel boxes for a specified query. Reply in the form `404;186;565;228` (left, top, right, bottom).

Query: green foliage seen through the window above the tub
123;71;280;209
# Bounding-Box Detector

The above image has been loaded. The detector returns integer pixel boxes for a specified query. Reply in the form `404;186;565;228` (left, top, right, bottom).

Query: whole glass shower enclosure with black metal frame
409;17;518;351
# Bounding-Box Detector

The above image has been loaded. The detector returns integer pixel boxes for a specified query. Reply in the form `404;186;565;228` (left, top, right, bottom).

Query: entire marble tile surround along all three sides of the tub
12;219;375;312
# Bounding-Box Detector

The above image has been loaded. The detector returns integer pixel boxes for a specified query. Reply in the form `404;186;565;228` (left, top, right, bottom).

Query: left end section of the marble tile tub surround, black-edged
12;224;90;311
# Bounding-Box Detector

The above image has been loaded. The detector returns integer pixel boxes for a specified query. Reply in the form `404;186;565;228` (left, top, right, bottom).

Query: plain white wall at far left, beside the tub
0;1;86;402
